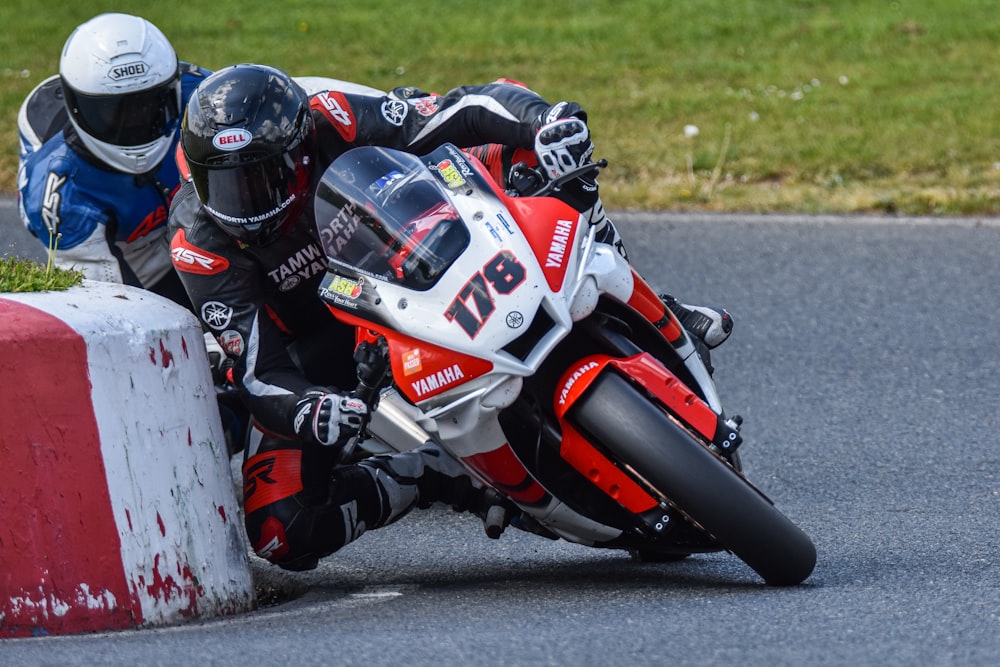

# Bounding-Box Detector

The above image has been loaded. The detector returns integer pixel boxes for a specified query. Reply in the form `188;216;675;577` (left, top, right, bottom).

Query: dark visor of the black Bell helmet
188;142;310;243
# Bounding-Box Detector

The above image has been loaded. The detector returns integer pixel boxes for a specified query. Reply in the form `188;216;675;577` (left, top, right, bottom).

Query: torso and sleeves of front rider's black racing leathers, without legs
169;82;583;437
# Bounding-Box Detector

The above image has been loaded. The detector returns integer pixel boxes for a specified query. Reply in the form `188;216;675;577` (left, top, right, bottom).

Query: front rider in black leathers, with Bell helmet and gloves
169;65;736;570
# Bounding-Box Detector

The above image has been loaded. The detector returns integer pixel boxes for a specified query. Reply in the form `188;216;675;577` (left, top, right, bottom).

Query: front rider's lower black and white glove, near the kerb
292;387;368;446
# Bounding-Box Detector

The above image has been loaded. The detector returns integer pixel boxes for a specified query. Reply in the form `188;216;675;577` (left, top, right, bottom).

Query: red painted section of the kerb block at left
0;299;142;637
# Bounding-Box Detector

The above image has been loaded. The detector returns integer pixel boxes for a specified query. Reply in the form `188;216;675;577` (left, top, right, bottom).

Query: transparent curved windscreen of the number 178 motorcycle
314;146;470;291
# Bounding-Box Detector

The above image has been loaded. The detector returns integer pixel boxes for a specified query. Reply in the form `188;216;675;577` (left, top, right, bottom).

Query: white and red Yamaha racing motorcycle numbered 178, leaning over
315;144;816;585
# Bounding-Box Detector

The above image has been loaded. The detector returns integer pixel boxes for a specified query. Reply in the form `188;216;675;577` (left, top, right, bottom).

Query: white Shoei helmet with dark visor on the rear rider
59;14;181;174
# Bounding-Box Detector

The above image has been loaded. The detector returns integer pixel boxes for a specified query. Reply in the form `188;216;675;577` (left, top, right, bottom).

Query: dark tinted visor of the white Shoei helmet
63;77;180;146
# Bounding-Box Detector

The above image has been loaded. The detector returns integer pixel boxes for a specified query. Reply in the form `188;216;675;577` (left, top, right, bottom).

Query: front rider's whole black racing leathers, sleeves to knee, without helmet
169;83;583;570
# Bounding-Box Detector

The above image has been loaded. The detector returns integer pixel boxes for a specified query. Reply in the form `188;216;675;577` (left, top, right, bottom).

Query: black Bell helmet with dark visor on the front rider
181;65;316;245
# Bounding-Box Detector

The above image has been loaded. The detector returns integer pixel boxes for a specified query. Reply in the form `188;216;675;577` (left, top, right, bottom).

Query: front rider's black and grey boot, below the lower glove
357;444;514;537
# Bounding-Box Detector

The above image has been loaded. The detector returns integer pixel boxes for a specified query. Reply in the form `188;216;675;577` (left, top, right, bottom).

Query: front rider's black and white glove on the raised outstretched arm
535;118;597;211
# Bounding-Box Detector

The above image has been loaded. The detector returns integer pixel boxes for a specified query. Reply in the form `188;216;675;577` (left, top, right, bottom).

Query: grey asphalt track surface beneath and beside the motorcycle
0;200;1000;666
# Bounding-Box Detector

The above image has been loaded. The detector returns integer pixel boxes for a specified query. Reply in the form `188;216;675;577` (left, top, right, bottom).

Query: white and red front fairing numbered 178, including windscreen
316;145;592;376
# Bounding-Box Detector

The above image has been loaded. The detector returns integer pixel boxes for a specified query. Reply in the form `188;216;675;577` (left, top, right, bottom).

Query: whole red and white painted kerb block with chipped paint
0;281;254;638
